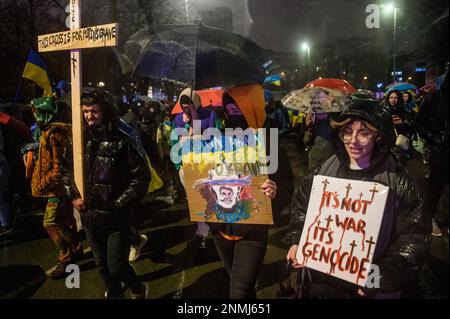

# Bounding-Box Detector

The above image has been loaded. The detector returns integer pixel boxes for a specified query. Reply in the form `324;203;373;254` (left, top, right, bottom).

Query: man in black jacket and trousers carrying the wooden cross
68;89;150;299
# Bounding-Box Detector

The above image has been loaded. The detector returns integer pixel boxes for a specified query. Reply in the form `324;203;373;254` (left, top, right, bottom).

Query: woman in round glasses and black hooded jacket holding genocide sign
287;100;431;299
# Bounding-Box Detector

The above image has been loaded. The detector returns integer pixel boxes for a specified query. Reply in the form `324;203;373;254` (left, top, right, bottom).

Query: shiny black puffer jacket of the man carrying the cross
85;127;150;211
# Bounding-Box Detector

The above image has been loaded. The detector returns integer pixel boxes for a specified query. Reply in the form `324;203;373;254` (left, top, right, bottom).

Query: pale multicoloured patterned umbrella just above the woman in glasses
281;87;348;113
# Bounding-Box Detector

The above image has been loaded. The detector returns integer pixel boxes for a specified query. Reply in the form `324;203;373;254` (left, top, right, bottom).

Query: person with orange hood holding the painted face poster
208;85;293;299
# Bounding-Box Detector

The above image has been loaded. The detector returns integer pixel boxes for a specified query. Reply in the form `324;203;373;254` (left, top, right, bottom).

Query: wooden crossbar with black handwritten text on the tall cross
38;23;119;52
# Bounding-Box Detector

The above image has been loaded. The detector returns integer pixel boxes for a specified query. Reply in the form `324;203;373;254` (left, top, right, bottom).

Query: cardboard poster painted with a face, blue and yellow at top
183;138;273;225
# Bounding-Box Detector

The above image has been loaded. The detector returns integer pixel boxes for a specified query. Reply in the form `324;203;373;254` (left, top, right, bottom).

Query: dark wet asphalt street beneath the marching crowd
0;134;449;299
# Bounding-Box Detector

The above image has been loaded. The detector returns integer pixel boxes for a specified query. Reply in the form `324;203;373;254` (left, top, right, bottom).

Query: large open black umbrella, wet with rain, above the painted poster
133;25;269;90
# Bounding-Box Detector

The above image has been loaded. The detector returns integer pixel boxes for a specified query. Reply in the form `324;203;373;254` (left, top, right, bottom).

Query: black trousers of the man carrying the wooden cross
84;226;142;298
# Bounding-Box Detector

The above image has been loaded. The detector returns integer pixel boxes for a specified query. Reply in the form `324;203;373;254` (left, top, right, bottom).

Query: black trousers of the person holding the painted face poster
213;231;268;299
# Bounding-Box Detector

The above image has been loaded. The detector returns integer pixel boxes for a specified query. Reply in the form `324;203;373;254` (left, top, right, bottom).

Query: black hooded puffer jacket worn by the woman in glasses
291;100;431;293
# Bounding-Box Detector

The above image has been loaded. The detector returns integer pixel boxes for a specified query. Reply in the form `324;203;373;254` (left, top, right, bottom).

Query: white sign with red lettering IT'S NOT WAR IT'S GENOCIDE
297;175;389;287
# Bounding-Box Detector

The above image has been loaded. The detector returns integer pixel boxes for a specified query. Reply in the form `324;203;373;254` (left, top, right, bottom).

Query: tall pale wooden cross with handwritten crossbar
38;0;119;198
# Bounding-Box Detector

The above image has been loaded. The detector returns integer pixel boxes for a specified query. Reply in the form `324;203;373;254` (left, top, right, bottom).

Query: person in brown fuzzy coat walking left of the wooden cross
31;97;83;279
